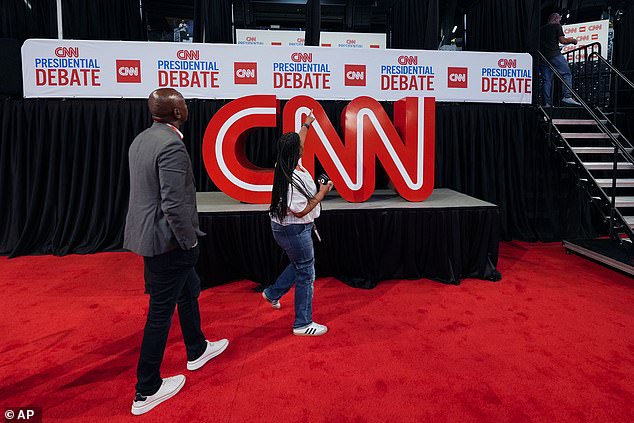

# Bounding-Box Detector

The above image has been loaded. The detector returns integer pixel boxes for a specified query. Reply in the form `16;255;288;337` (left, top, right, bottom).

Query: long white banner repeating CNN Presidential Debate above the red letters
22;40;533;103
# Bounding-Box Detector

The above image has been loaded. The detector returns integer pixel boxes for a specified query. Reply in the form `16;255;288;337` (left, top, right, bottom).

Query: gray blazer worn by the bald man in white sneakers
123;123;205;257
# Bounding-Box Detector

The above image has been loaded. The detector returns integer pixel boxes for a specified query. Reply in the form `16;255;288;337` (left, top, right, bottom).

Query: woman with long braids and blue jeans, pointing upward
262;112;332;336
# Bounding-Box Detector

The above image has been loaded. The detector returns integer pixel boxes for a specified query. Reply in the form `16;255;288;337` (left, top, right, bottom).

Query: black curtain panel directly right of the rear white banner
389;0;440;50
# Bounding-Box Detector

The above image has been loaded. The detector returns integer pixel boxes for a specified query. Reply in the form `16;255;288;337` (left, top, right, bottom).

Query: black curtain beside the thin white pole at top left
62;0;147;41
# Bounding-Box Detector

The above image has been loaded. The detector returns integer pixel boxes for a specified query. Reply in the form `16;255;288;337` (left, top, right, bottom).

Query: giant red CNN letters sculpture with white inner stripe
202;95;435;204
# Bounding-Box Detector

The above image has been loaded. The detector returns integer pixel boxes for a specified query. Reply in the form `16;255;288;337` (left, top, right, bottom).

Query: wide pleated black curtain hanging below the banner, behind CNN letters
0;99;602;255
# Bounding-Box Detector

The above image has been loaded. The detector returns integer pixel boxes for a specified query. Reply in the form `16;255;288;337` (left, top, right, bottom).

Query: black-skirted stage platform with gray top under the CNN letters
197;189;501;288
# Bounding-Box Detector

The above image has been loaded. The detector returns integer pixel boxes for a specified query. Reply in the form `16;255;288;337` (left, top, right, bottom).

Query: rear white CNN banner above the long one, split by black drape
236;29;387;48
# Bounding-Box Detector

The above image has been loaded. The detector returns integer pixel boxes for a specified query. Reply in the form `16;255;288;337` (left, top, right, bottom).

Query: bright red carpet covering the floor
0;243;634;423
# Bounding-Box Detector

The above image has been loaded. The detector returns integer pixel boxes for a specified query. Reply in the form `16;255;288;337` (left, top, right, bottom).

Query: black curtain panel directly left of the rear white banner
194;0;233;44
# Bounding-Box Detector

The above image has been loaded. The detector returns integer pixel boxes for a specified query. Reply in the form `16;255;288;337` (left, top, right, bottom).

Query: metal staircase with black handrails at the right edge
539;48;634;275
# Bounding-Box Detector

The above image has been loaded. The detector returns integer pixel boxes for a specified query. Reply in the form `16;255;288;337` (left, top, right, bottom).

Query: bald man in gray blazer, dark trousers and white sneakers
123;88;229;415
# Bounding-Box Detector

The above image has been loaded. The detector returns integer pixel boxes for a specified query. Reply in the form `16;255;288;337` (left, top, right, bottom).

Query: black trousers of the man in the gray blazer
136;247;207;396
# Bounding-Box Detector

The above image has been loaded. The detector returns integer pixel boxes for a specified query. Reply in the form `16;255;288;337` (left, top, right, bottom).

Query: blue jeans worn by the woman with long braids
264;222;315;329
